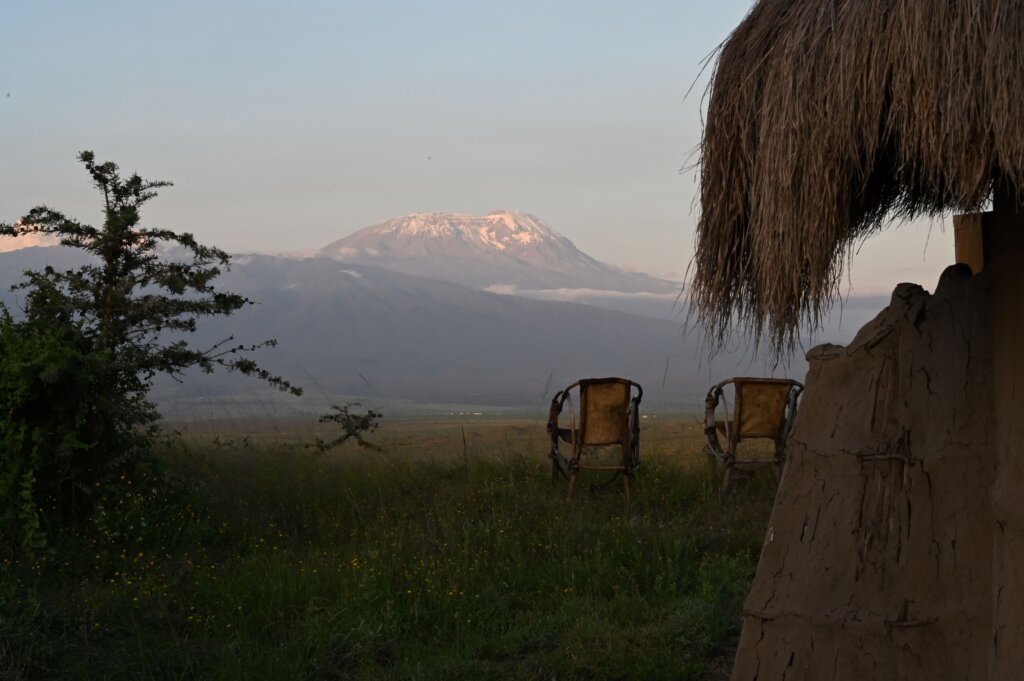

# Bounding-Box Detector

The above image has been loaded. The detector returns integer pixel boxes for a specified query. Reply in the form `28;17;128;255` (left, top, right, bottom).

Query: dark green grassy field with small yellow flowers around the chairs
0;420;773;681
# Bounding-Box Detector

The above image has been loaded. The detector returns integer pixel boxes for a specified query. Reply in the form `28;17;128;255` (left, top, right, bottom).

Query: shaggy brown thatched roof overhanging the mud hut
691;0;1024;349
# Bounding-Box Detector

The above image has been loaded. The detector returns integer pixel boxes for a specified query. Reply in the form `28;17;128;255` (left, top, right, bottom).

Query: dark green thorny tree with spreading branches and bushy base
0;152;301;539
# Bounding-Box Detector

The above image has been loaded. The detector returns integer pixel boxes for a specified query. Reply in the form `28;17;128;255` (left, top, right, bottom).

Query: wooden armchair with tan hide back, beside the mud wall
705;378;804;496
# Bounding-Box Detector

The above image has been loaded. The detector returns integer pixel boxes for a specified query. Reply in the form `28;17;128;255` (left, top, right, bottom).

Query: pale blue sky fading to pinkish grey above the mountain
6;0;952;293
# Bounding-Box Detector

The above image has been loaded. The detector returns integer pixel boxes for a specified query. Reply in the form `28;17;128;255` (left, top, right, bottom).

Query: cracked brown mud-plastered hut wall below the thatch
732;265;995;681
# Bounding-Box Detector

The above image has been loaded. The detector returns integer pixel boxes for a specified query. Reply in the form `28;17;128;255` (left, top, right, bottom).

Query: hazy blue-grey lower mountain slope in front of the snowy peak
0;248;886;410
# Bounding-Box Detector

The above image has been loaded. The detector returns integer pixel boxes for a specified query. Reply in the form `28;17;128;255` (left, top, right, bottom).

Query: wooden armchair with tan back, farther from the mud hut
548;378;643;500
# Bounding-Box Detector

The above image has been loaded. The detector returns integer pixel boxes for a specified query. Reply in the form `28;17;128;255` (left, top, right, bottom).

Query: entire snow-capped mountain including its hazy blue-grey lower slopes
0;211;860;417
